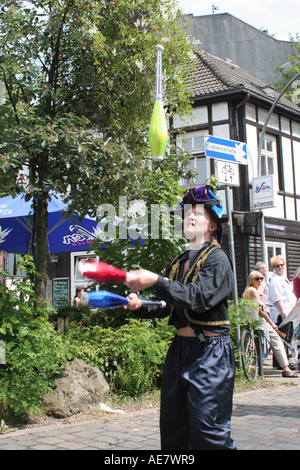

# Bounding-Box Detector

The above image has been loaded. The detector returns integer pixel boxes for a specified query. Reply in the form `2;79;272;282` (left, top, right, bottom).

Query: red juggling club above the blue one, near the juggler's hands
78;261;126;284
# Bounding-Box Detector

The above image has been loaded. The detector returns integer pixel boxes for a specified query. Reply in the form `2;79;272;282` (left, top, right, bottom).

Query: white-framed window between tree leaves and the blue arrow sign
177;130;210;187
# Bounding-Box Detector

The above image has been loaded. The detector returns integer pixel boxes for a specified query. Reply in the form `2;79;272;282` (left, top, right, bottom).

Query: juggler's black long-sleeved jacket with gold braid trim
138;243;234;334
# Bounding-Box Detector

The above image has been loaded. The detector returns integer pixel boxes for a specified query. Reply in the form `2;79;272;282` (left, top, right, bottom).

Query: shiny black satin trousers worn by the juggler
160;336;236;450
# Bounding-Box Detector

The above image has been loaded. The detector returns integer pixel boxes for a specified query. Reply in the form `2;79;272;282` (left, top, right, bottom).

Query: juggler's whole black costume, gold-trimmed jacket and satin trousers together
139;243;235;450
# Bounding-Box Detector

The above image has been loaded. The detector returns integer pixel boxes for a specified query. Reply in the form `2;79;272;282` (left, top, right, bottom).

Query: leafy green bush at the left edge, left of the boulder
0;257;67;420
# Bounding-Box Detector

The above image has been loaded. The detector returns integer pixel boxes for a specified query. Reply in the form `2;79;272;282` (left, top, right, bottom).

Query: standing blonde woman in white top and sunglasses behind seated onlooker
268;255;297;323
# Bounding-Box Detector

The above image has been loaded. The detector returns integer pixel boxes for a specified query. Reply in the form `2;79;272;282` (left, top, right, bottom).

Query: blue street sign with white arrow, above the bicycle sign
204;135;248;165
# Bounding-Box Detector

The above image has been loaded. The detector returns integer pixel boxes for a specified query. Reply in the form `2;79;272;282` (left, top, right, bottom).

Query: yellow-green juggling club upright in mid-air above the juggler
149;45;168;162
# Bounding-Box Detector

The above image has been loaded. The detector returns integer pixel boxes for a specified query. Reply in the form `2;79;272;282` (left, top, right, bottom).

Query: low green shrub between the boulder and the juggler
65;319;174;397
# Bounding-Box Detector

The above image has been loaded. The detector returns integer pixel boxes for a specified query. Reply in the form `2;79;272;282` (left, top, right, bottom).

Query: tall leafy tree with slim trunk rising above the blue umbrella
0;0;190;298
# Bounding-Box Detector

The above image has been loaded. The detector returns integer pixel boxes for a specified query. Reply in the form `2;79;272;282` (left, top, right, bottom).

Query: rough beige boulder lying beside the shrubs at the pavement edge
44;359;109;418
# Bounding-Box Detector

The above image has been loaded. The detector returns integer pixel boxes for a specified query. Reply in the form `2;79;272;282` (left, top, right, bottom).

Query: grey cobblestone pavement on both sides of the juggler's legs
0;371;300;451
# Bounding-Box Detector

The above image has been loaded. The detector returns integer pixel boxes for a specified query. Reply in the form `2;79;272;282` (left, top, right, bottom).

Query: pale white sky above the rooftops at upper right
177;0;300;41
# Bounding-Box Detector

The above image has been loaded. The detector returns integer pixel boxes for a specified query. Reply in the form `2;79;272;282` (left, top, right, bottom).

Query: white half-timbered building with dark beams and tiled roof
172;50;300;295
